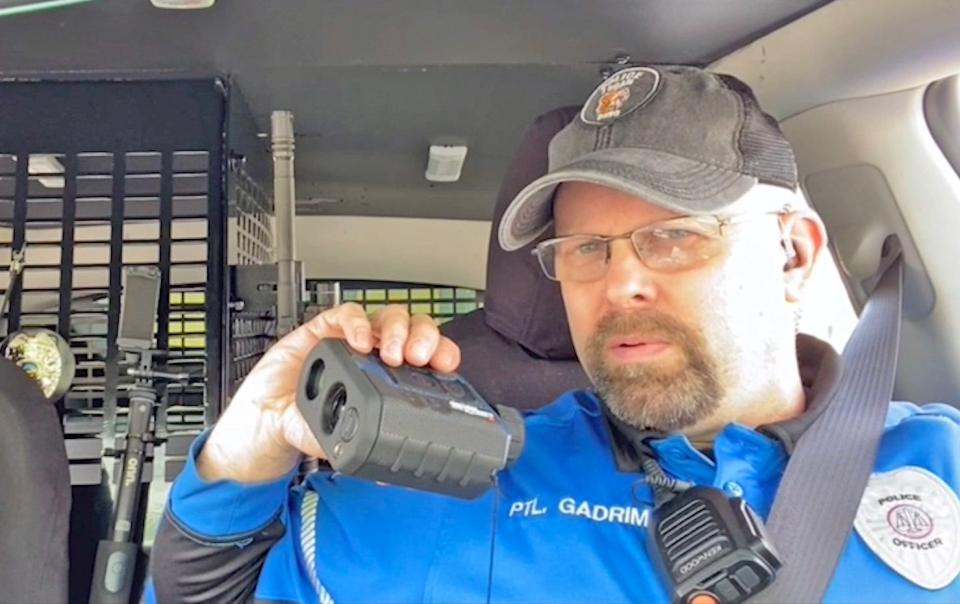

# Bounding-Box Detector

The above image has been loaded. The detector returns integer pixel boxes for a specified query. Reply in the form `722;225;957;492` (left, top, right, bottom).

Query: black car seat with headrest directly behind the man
441;107;590;409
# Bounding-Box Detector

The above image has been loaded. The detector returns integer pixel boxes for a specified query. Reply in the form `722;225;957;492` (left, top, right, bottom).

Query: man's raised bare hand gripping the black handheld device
197;303;460;483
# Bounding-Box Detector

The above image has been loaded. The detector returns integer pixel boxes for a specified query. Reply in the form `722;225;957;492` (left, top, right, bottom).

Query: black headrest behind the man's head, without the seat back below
484;107;580;360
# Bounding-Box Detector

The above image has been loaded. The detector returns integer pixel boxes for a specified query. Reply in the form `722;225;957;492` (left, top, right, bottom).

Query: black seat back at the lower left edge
0;358;70;604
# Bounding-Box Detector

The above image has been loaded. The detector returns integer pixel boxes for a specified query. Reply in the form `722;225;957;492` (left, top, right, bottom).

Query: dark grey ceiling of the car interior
0;0;827;220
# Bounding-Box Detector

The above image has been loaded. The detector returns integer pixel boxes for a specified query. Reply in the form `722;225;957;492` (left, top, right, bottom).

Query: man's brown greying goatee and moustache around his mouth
584;311;723;432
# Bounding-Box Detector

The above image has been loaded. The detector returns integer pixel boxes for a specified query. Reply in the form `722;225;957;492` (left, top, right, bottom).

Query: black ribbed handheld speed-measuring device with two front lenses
297;339;524;499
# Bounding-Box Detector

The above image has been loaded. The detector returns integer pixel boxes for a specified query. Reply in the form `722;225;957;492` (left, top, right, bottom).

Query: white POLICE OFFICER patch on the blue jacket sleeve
853;466;960;589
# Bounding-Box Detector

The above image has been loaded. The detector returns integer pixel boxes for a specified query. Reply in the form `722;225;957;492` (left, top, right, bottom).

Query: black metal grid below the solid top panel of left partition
0;151;220;476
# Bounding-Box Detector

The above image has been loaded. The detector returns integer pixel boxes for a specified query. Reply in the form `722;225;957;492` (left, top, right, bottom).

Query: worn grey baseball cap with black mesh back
499;65;797;251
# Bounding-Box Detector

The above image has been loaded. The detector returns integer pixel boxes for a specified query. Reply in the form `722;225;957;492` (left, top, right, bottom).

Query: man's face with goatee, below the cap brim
554;182;796;432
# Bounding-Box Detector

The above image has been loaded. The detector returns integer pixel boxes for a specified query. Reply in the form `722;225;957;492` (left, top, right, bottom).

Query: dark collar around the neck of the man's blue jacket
601;334;842;472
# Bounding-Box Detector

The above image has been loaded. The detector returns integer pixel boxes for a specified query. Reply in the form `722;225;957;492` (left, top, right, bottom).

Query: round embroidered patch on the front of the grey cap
580;67;660;126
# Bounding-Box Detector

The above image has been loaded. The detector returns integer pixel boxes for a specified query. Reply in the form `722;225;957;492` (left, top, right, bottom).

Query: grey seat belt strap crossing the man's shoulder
750;235;903;604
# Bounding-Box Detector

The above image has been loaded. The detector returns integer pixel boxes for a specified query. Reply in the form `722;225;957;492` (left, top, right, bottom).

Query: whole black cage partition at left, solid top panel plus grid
0;79;227;601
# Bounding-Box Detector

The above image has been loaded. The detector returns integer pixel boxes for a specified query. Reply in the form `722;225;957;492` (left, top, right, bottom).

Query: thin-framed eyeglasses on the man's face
532;211;783;282
